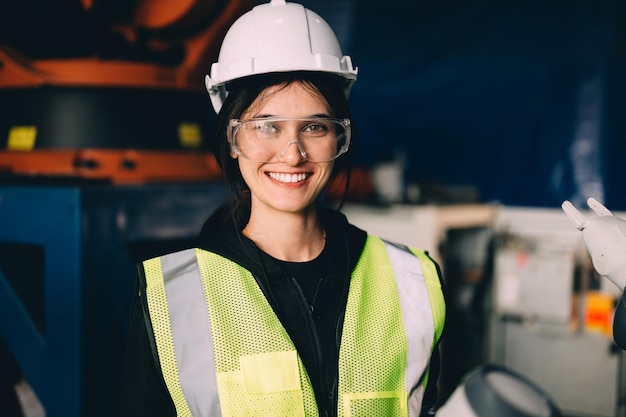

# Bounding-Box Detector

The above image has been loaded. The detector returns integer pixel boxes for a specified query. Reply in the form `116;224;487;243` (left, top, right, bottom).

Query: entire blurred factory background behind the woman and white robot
0;0;626;417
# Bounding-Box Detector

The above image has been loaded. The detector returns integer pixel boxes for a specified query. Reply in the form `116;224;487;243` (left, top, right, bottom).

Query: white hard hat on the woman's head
205;0;357;113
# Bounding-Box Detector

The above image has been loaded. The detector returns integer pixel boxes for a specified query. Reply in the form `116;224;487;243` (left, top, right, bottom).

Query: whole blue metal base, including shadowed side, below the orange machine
0;183;226;417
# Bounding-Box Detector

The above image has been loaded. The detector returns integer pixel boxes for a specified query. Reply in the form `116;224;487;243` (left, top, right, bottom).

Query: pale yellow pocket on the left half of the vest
217;351;305;417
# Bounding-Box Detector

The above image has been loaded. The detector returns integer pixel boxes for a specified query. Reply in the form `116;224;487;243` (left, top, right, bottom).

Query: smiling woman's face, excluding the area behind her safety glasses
231;82;334;218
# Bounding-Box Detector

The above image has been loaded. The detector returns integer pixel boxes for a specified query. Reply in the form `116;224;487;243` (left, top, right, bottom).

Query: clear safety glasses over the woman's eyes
228;117;350;162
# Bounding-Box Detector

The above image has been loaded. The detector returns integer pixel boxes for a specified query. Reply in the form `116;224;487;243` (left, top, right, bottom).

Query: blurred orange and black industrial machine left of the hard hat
0;0;254;184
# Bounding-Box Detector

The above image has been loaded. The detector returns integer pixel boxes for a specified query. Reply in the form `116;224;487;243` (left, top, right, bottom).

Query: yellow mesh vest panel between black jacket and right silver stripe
339;236;408;417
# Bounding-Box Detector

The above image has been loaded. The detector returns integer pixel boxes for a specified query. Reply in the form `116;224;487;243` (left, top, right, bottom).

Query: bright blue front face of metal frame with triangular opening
0;187;81;417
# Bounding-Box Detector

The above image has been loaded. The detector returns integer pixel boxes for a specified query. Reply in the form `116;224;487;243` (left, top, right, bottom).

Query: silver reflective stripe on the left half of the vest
161;249;221;417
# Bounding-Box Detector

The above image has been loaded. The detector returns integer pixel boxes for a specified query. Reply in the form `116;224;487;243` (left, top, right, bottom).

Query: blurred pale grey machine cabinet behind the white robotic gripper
485;202;626;417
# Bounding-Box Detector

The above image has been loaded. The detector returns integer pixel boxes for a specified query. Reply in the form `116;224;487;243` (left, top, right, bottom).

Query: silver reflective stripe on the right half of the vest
383;239;435;417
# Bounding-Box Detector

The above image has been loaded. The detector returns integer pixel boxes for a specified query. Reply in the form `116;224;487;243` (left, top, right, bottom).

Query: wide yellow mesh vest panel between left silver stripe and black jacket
196;249;317;417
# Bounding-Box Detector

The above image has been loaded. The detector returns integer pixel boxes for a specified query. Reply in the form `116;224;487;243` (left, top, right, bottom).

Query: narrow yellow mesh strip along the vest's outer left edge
143;258;191;417
